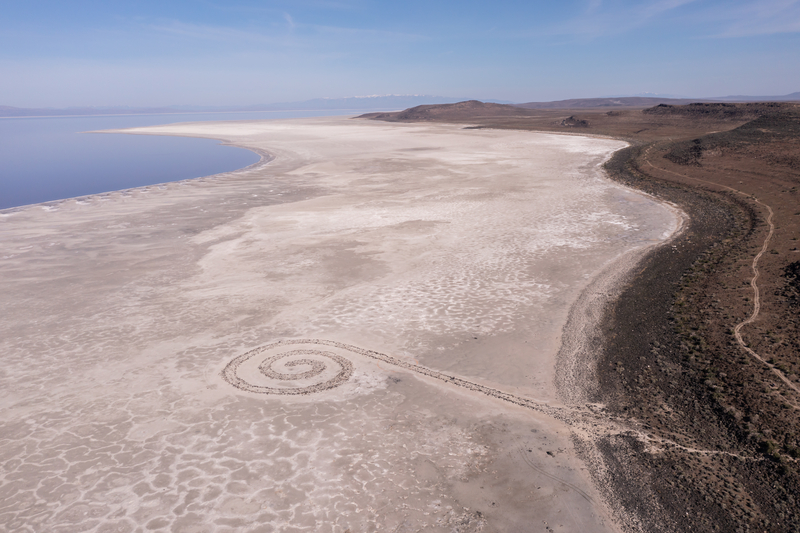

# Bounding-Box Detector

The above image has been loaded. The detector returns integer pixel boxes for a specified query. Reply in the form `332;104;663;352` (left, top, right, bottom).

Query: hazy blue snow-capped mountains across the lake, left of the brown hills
0;94;511;117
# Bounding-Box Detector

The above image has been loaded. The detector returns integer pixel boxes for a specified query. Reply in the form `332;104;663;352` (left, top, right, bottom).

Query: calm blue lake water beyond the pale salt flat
0;110;362;209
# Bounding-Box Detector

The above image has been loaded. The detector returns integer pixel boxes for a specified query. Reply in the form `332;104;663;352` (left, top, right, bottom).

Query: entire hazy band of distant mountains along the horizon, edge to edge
0;92;800;117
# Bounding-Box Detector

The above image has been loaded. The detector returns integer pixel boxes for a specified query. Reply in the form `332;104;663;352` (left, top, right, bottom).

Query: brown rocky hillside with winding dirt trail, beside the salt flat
365;102;800;532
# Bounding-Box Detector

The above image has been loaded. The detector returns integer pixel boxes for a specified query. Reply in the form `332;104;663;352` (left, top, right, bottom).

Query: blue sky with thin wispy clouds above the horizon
0;0;800;107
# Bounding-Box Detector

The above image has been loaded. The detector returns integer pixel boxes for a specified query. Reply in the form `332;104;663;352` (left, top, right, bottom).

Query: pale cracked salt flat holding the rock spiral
0;118;678;533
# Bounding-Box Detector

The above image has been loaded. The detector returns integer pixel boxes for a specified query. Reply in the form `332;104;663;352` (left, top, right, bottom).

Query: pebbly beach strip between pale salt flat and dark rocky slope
555;145;692;533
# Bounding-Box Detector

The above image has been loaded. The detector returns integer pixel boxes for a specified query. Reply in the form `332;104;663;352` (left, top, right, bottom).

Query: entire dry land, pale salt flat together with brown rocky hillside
0;98;800;533
